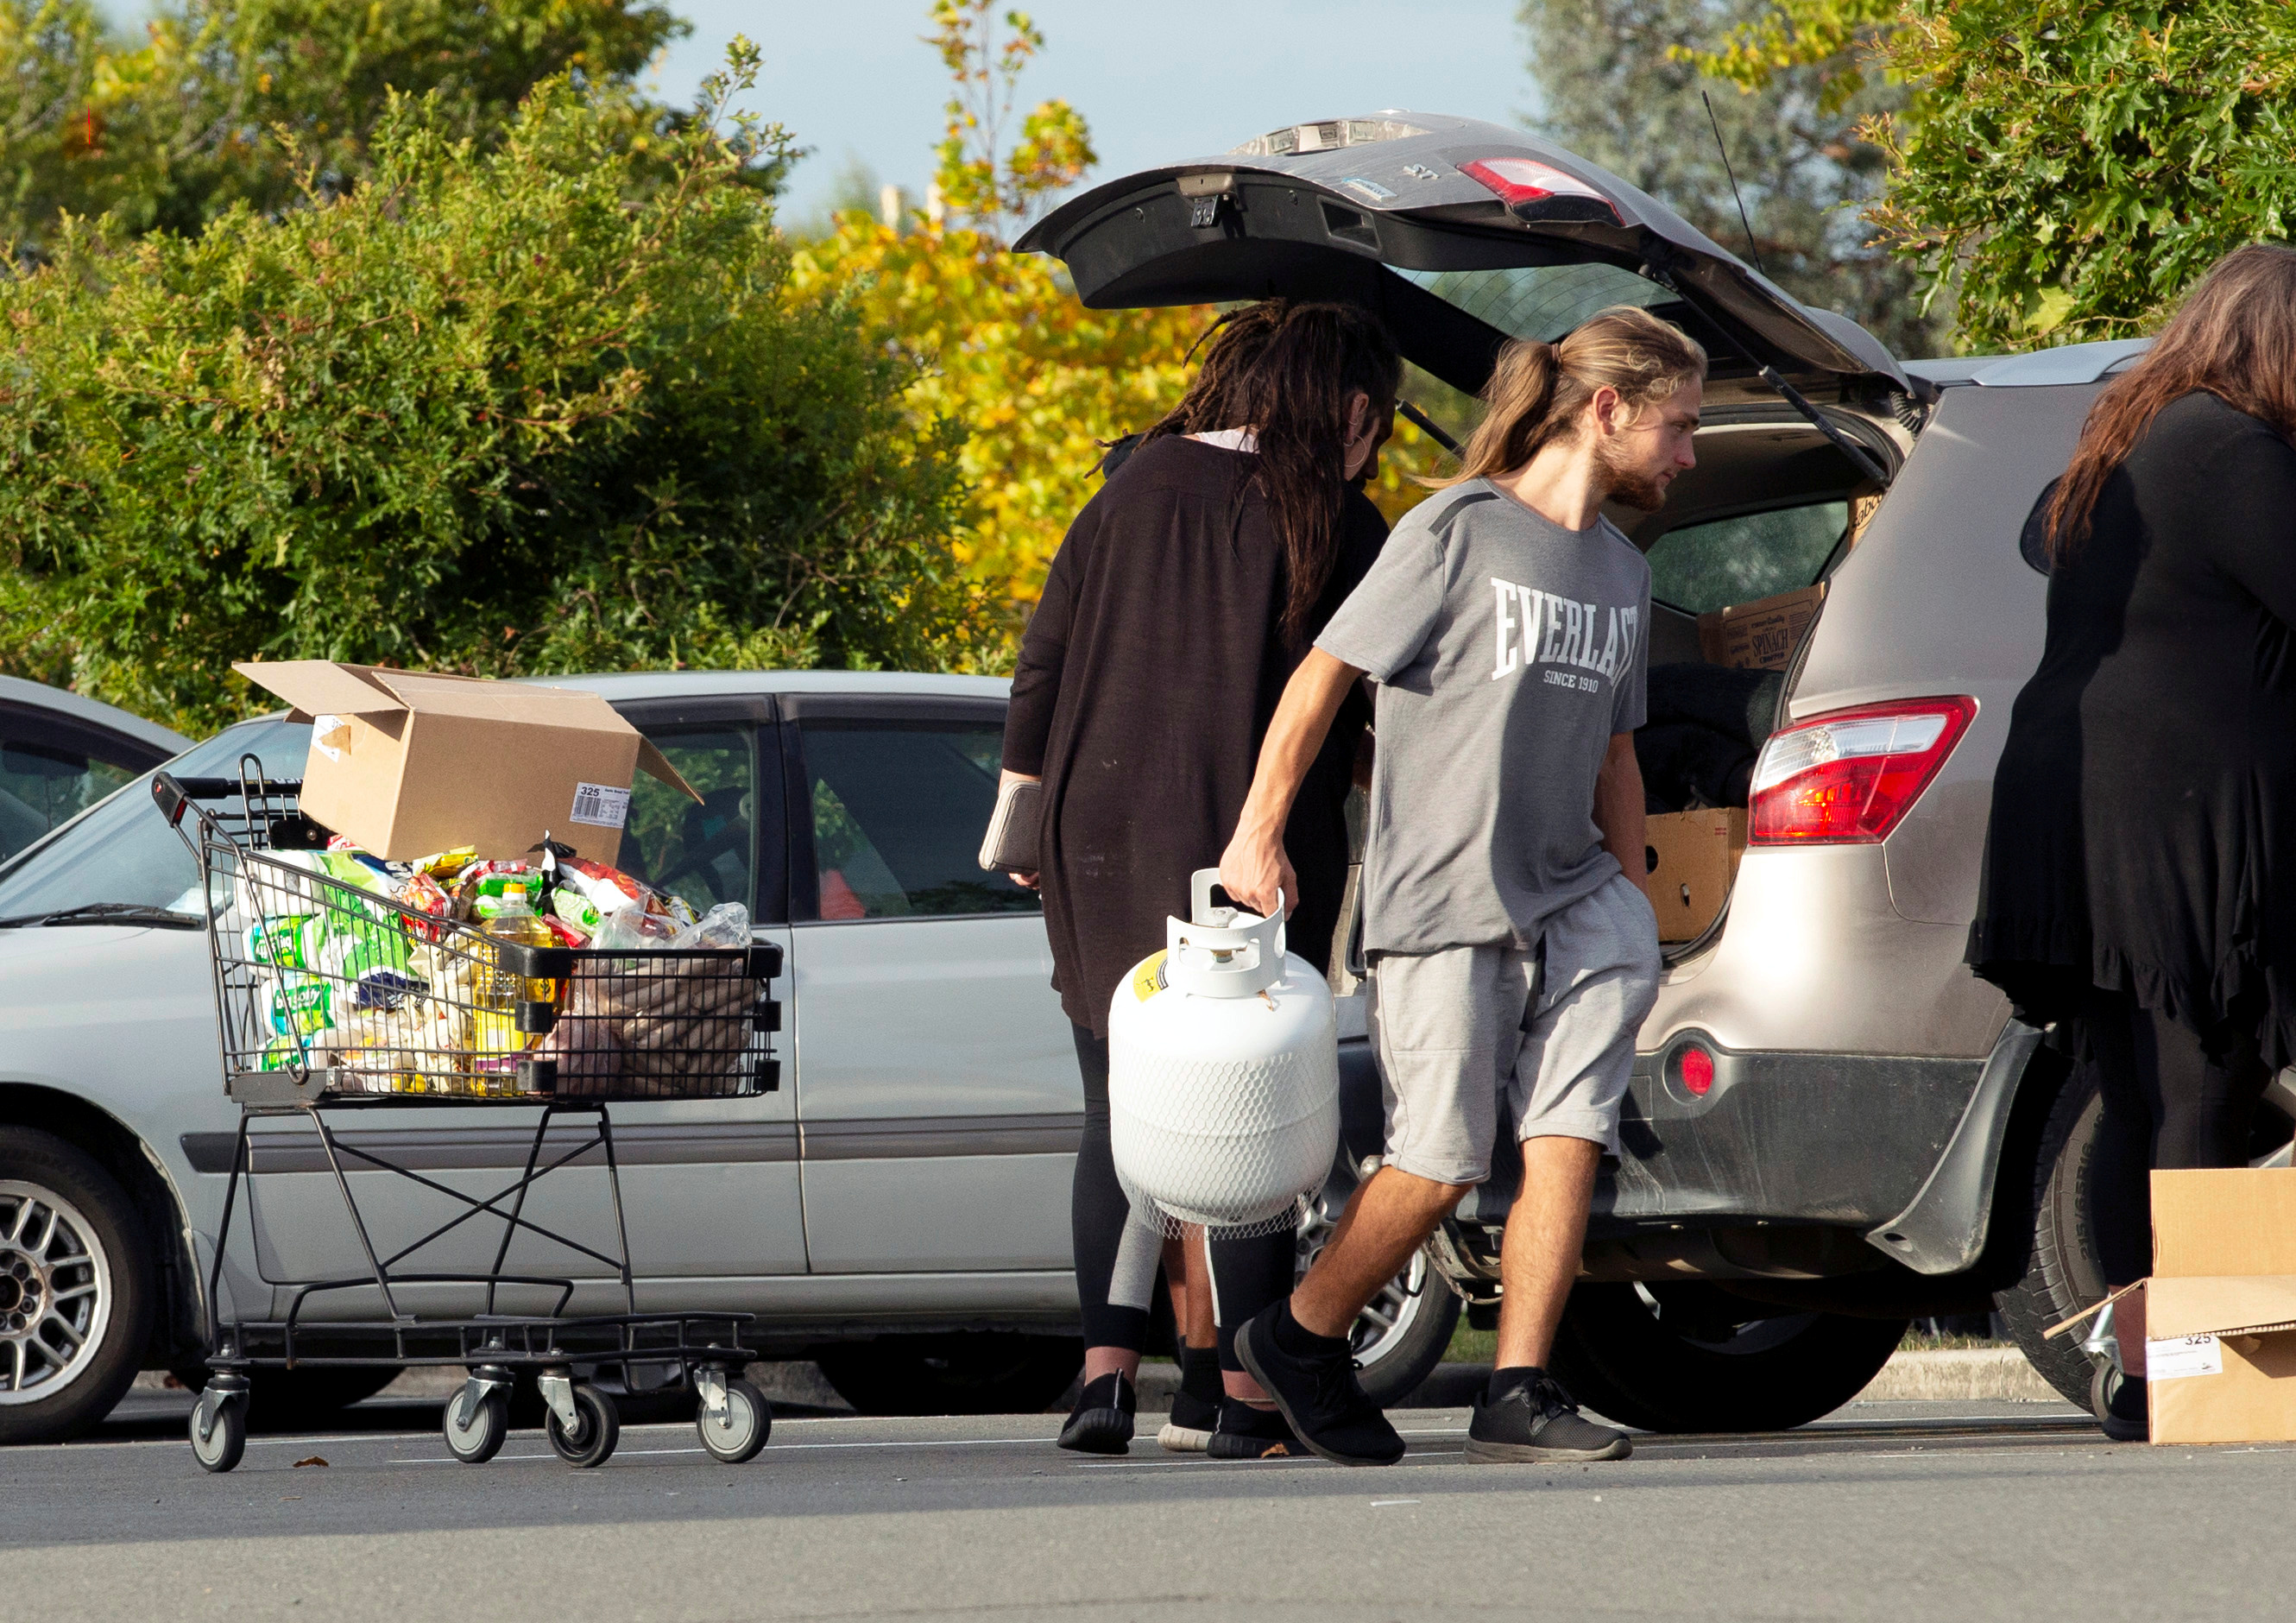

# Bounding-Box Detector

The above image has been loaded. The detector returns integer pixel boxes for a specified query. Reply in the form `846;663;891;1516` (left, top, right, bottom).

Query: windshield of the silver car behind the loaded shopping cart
0;721;310;919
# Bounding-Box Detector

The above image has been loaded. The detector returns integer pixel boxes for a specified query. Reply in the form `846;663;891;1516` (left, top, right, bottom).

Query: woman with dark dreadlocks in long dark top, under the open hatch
1003;300;1403;1458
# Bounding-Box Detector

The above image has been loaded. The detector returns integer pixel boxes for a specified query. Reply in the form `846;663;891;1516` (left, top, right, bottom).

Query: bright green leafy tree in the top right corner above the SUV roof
1871;0;2296;349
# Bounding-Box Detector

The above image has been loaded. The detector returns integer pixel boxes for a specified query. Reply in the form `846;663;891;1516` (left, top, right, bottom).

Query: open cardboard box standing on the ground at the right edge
2144;1166;2296;1444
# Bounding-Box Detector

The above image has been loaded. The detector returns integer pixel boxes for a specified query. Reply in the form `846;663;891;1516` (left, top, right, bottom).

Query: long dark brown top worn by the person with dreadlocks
1003;436;1387;1035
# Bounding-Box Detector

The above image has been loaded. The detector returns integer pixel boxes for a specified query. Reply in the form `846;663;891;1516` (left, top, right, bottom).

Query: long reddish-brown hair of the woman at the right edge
2048;243;2296;565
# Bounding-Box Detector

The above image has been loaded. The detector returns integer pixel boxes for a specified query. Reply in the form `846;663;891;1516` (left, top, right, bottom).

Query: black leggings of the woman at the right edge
2080;987;2271;1288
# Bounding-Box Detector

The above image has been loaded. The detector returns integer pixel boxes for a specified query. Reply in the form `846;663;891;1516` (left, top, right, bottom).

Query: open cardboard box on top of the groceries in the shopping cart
232;659;700;863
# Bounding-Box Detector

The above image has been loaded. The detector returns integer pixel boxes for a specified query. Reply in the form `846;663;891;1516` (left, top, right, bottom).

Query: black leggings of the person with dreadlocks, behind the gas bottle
1070;1026;1297;1370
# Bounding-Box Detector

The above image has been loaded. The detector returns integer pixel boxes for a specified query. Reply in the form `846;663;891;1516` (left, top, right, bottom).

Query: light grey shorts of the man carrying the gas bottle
1371;875;1658;1184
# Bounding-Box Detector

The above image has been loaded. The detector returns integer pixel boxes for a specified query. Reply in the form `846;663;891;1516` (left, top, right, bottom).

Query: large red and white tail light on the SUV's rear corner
1747;698;1977;845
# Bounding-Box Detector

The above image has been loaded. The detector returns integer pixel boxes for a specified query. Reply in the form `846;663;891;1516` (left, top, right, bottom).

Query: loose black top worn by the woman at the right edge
1970;393;2296;1067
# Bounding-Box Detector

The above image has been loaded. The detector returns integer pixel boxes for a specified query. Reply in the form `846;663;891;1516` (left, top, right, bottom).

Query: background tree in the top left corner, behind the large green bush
0;0;716;250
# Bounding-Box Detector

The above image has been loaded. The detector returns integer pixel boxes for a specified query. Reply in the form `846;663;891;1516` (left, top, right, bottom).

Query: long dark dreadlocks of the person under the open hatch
1148;299;1403;645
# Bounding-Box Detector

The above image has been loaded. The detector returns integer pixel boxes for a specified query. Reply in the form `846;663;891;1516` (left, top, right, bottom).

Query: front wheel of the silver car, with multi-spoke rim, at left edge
0;1127;159;1444
